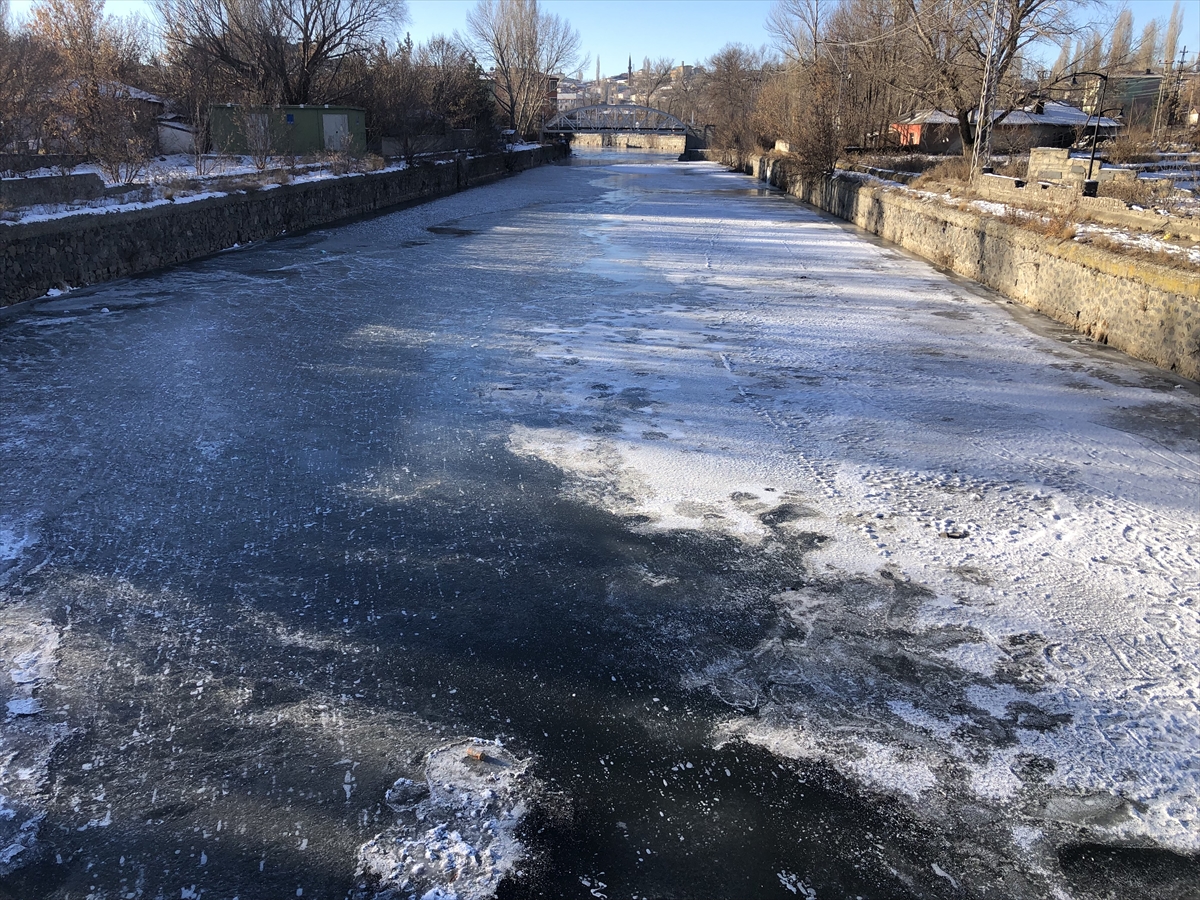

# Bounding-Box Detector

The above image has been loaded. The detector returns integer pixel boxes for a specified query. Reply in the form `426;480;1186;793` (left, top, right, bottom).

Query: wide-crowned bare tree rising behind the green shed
152;0;408;103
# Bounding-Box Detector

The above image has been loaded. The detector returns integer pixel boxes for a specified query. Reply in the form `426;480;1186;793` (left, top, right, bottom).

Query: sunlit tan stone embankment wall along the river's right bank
740;157;1200;380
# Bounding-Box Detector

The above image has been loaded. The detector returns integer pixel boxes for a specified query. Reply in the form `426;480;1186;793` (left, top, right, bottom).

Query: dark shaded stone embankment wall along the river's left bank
0;146;565;307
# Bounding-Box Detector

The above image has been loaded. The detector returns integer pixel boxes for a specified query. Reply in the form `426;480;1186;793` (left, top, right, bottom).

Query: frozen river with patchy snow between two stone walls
0;154;1200;900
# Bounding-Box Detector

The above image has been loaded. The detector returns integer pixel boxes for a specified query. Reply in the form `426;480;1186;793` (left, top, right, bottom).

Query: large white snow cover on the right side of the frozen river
510;167;1200;868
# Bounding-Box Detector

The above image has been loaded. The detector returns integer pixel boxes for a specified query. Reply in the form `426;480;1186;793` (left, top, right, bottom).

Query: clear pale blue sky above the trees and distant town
12;0;1200;76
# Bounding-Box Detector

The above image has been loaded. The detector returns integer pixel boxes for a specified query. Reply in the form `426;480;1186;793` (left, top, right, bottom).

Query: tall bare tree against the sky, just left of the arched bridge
467;0;580;136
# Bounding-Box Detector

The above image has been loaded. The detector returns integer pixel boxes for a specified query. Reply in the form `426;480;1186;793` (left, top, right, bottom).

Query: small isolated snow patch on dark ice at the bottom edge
359;739;540;900
